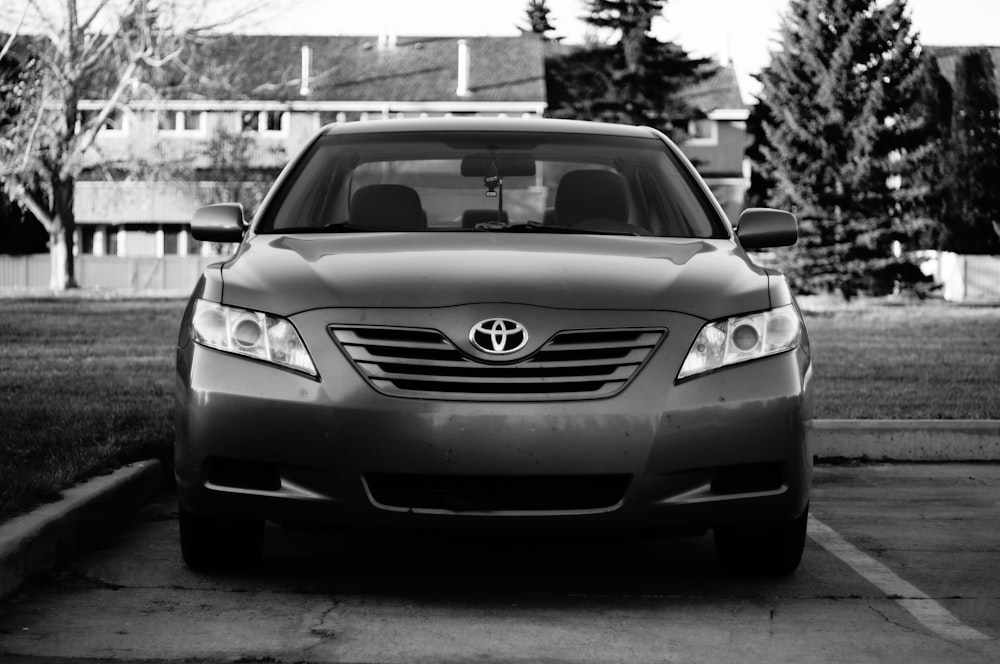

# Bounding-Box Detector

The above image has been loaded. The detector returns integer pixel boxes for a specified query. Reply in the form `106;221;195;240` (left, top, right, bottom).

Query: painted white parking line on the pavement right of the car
808;515;990;641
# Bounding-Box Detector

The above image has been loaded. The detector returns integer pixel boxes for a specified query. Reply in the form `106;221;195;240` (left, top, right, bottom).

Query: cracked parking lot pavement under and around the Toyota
0;464;1000;664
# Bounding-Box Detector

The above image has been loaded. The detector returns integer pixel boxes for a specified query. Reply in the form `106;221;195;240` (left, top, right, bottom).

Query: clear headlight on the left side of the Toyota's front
191;300;316;376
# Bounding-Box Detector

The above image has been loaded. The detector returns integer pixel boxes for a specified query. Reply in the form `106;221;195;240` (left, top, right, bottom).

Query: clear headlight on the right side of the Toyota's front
677;305;802;380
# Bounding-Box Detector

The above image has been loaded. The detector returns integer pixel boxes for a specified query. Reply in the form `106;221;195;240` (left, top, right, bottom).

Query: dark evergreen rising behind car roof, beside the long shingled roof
546;0;712;131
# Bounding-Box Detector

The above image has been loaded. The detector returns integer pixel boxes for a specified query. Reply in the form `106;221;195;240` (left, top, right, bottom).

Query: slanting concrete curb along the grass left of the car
0;459;169;601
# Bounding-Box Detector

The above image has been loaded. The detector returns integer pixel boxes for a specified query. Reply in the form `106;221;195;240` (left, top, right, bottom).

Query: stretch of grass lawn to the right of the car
806;302;1000;420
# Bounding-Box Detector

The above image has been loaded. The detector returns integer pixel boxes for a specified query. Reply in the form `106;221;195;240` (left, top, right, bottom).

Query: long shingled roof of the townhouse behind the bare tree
159;35;545;102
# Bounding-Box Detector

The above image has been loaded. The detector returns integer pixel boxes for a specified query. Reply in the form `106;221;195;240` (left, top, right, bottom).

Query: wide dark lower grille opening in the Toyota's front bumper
365;473;630;512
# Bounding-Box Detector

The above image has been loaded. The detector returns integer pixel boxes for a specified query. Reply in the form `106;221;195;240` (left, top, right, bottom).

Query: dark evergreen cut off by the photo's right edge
940;49;1000;254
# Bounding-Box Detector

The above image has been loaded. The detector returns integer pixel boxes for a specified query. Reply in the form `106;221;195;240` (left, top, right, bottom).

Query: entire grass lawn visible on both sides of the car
0;298;1000;521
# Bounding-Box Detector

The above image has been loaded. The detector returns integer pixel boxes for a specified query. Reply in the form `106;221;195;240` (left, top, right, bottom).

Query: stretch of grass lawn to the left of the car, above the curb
0;299;184;521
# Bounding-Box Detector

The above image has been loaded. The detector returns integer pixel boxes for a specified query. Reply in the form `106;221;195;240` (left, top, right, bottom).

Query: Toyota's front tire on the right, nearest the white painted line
715;505;809;576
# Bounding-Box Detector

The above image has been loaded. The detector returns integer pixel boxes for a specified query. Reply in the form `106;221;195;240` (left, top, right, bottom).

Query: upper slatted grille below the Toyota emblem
330;326;665;401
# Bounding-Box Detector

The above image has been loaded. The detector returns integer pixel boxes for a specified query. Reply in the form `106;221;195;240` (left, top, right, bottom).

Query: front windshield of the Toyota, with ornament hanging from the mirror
257;131;728;238
